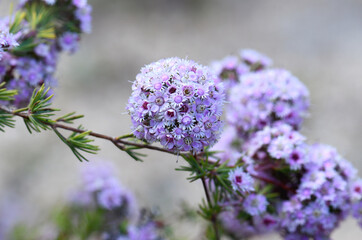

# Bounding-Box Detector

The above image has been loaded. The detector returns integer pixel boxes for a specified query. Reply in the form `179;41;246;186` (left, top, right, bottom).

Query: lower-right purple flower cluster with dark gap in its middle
220;123;362;239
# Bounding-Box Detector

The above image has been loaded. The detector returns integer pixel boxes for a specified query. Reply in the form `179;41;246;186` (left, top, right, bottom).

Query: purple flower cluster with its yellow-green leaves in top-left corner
0;0;92;107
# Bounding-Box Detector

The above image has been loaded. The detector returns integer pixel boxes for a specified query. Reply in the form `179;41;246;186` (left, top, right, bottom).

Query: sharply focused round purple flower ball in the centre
127;58;224;152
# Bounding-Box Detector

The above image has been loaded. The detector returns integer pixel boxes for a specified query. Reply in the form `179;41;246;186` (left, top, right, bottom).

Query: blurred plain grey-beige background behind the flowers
0;0;362;240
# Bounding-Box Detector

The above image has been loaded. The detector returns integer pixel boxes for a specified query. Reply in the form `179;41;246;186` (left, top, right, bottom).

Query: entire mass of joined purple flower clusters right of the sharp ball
211;50;362;240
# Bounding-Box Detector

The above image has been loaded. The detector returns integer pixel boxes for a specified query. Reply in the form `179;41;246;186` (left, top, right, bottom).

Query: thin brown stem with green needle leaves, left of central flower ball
0;83;176;161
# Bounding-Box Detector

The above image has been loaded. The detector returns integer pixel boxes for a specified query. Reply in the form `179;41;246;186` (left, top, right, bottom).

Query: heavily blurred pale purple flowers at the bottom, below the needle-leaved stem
72;162;168;240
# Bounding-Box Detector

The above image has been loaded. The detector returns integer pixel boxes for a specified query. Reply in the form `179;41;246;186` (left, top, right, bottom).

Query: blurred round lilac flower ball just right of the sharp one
226;69;309;135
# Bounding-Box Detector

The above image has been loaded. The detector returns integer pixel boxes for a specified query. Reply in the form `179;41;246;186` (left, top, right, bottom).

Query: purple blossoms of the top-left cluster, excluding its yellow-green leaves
0;0;91;107
